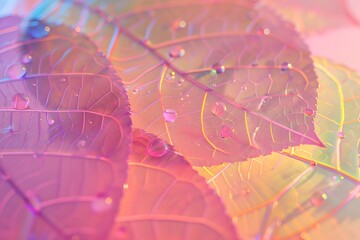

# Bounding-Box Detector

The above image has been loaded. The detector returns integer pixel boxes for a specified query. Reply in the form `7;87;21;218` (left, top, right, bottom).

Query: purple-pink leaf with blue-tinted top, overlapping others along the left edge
0;17;131;239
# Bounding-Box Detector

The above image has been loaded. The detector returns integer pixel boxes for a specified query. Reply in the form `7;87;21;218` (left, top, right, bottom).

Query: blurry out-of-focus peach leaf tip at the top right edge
261;0;360;34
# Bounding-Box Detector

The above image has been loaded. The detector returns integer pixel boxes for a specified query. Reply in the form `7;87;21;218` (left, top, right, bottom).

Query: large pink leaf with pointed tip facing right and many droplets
31;0;323;166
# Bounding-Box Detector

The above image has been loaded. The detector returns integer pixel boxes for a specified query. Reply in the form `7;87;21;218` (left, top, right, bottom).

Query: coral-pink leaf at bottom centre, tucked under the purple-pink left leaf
111;130;238;240
